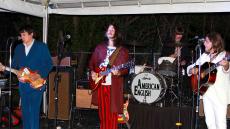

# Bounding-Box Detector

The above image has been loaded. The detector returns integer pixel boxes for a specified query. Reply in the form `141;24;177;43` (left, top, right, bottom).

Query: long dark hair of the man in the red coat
105;24;122;47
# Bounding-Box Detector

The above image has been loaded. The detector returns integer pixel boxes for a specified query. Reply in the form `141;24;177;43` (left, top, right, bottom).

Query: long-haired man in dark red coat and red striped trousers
89;24;128;129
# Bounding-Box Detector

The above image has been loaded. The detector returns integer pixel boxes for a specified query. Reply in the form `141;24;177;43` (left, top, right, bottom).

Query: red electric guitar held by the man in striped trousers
89;61;134;92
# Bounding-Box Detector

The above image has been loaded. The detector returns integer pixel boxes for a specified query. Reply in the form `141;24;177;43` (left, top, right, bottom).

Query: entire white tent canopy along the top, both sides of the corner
0;0;230;17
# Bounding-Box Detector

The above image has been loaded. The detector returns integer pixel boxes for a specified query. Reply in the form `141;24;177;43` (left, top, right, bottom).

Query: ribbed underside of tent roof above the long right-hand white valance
47;0;230;8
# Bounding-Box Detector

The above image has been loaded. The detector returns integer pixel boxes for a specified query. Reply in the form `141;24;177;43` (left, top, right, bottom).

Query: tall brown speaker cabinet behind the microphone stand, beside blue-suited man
48;68;73;120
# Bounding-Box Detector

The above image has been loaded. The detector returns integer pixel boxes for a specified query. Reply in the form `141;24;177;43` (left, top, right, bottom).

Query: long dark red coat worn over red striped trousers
89;42;128;113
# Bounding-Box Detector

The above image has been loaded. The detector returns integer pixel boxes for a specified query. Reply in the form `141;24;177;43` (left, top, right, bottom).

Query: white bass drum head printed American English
131;72;167;104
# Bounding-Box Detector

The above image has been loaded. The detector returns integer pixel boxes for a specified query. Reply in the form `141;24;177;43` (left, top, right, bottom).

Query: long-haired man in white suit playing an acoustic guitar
187;32;230;129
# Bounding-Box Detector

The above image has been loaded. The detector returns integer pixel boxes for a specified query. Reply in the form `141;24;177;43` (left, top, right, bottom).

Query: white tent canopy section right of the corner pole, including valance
49;0;230;15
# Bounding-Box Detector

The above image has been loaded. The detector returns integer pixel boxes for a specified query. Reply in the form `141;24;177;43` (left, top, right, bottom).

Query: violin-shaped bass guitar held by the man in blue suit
0;63;46;89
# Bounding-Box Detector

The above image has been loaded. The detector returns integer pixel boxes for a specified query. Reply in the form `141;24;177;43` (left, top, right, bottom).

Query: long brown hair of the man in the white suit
207;32;224;53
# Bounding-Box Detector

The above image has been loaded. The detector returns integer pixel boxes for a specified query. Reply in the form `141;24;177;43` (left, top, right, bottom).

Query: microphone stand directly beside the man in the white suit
195;40;202;129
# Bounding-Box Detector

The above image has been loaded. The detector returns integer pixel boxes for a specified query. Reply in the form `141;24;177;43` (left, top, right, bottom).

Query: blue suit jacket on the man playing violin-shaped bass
12;41;52;92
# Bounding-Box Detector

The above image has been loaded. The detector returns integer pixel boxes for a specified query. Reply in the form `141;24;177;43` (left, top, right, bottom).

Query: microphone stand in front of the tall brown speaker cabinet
53;41;64;129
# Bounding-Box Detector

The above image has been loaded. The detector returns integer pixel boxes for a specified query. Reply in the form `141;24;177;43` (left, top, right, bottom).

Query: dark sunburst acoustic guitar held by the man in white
191;56;230;95
